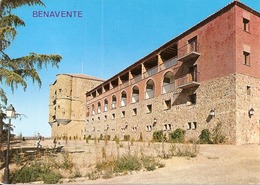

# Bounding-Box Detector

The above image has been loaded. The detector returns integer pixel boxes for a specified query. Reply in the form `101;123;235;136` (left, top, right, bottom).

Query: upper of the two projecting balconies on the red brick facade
178;42;200;62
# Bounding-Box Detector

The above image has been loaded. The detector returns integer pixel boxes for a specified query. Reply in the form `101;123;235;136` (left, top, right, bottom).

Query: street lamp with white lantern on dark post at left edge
4;104;15;184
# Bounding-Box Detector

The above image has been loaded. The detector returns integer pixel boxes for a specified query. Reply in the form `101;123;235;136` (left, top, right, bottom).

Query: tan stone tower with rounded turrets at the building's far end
49;74;103;138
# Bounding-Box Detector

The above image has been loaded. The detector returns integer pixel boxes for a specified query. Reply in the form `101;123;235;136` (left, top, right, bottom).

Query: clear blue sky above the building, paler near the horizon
4;0;260;136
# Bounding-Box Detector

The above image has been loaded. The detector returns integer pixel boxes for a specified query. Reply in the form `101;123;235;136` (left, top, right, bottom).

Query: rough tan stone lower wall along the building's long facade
86;74;252;144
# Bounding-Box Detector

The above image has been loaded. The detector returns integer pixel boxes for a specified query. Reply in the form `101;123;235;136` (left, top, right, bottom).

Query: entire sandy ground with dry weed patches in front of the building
1;140;260;184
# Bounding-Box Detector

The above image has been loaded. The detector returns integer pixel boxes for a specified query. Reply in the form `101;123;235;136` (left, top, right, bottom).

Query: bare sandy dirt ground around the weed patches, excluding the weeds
0;140;260;184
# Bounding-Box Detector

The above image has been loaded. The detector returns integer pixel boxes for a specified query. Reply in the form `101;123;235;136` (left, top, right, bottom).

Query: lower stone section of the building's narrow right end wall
236;74;260;144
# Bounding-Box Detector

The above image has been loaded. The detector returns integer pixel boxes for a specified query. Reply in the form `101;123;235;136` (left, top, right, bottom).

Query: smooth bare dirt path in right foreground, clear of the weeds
69;145;260;184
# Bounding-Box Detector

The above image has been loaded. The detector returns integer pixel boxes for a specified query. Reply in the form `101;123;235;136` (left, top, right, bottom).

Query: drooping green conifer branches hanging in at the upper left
0;0;62;136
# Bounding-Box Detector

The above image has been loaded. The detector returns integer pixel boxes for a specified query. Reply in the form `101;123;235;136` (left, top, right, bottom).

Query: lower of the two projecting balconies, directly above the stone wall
176;72;200;89
